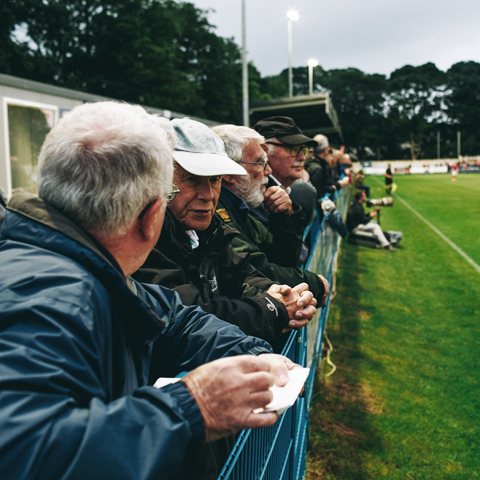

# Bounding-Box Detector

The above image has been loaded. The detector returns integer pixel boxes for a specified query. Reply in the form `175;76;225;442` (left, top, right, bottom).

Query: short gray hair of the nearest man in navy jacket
38;102;175;238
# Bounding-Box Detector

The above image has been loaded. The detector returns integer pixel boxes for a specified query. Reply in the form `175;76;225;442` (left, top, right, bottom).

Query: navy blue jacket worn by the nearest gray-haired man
0;193;270;480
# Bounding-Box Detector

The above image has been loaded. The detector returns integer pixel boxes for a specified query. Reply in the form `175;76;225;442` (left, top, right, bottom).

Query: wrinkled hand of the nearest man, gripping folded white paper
181;354;295;442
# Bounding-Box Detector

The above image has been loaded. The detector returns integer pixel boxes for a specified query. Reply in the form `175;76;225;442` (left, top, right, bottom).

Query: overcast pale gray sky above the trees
189;0;480;76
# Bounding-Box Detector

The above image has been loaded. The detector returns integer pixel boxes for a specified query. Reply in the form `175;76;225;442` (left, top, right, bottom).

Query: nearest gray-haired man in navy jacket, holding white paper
0;102;293;480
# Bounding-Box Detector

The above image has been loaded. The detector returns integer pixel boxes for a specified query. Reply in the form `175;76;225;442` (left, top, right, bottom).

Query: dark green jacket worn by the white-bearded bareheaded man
217;187;325;301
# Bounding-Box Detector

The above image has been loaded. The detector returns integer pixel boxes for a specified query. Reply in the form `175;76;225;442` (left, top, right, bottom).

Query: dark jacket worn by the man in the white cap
133;209;289;344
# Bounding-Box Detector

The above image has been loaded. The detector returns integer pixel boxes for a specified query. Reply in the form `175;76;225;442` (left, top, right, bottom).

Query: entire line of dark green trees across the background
0;0;480;159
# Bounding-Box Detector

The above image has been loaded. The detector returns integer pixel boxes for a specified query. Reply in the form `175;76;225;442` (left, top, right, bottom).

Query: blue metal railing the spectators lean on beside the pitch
218;188;349;480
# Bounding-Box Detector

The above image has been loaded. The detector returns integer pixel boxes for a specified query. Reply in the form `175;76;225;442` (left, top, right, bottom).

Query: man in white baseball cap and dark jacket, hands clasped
133;118;315;346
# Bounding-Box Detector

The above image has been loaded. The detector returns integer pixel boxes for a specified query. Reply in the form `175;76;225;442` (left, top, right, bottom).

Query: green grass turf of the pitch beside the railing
306;174;480;480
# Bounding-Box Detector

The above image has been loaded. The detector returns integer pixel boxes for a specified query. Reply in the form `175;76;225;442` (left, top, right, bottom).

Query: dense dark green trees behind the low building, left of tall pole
3;0;248;121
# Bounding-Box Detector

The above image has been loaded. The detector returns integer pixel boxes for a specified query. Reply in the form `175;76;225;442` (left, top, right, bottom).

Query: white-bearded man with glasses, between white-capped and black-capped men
213;125;329;316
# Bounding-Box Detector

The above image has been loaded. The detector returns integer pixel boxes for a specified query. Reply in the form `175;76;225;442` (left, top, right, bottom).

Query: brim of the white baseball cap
173;150;247;177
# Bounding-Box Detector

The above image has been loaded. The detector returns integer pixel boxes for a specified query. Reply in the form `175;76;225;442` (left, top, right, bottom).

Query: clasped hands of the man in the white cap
267;283;317;332
